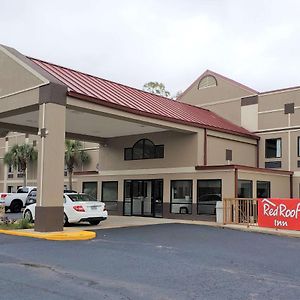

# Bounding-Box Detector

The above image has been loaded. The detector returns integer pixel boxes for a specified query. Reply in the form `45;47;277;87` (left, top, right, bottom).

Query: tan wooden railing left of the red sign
223;198;258;226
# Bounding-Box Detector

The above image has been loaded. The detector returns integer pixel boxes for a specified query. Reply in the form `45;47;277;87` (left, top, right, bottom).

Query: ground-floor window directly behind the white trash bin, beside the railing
197;179;222;215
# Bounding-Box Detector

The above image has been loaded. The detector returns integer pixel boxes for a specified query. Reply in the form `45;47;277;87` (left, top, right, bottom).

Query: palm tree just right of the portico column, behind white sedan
65;140;90;190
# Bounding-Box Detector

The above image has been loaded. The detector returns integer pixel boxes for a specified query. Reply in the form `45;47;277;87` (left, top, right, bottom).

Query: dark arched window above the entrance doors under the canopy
124;139;164;160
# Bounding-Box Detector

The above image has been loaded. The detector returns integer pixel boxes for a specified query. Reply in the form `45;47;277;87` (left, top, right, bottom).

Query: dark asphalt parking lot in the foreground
0;224;300;299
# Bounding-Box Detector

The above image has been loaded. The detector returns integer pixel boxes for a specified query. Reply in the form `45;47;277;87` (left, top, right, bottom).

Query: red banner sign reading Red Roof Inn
258;199;300;230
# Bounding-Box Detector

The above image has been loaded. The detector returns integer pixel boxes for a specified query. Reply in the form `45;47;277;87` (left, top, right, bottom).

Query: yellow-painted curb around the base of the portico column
0;229;96;241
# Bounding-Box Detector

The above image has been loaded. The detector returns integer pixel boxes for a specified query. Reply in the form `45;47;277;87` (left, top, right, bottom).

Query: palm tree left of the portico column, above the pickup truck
4;144;38;186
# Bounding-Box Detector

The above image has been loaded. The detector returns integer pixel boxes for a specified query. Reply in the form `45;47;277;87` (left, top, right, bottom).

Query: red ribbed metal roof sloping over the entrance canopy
29;58;258;139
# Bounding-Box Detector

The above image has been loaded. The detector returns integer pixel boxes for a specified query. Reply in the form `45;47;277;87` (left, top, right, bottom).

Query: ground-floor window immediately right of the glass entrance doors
171;180;193;214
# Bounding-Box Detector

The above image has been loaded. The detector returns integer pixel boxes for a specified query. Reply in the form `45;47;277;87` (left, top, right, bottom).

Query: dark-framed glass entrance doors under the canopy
124;179;163;217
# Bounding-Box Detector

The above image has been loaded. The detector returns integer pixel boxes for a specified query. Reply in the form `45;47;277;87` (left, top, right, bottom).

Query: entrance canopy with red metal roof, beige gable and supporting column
0;46;257;231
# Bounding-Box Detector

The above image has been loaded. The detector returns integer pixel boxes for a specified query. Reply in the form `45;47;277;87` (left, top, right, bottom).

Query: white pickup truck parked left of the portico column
0;186;36;213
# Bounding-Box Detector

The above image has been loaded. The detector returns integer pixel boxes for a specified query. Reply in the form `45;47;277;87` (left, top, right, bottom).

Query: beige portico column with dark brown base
34;103;66;232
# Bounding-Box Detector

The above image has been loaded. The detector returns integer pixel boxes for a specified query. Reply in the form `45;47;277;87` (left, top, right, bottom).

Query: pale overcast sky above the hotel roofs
0;0;300;95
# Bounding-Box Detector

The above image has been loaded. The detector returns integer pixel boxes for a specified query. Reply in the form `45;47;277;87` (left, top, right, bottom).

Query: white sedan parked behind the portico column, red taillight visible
23;193;107;225
